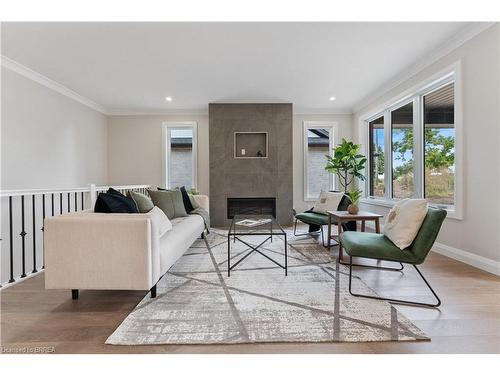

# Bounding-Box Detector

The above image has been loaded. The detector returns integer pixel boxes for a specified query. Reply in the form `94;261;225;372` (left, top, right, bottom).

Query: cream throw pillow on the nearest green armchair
383;199;427;250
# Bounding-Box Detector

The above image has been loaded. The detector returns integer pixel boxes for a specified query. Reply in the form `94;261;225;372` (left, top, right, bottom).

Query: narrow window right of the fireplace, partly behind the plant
304;121;336;201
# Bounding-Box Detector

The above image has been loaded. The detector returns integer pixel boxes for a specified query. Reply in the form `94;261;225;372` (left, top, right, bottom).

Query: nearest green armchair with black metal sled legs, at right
340;208;446;307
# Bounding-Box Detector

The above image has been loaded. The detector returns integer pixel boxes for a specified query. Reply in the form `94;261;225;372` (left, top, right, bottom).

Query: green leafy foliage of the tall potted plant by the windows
325;138;366;194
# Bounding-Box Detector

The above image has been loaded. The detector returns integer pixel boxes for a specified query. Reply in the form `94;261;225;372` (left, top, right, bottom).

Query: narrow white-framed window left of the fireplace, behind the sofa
163;123;197;189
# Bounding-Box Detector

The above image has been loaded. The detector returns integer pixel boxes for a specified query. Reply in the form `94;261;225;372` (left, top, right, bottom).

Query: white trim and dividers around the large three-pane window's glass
358;61;463;220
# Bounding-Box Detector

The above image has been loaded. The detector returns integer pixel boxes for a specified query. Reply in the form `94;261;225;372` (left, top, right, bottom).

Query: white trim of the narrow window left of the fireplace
161;121;198;189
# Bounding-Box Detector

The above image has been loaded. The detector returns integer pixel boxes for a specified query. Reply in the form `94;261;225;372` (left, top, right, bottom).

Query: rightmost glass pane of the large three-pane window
424;83;455;206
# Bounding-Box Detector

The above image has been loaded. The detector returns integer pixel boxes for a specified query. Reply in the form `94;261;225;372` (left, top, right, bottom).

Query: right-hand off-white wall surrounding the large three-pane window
353;25;500;272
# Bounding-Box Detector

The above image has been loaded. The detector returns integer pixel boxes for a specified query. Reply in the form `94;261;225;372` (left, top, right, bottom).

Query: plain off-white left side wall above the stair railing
1;67;107;190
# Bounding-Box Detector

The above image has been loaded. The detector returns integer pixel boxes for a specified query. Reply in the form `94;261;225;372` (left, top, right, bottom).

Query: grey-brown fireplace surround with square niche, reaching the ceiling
209;104;293;225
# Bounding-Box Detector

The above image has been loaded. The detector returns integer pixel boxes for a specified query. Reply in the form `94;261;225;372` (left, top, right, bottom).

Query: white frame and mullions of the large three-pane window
358;61;463;220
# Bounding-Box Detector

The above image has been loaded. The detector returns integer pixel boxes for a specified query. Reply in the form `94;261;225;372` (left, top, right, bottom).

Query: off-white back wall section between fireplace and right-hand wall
293;114;352;212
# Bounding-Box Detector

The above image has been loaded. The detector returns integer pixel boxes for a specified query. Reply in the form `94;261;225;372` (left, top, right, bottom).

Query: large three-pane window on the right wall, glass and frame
363;65;461;218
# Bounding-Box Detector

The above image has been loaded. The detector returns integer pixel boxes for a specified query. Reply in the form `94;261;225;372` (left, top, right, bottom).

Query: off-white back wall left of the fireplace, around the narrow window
108;115;210;194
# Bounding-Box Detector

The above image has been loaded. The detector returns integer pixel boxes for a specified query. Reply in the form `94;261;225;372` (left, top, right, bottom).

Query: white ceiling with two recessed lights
2;23;471;113
